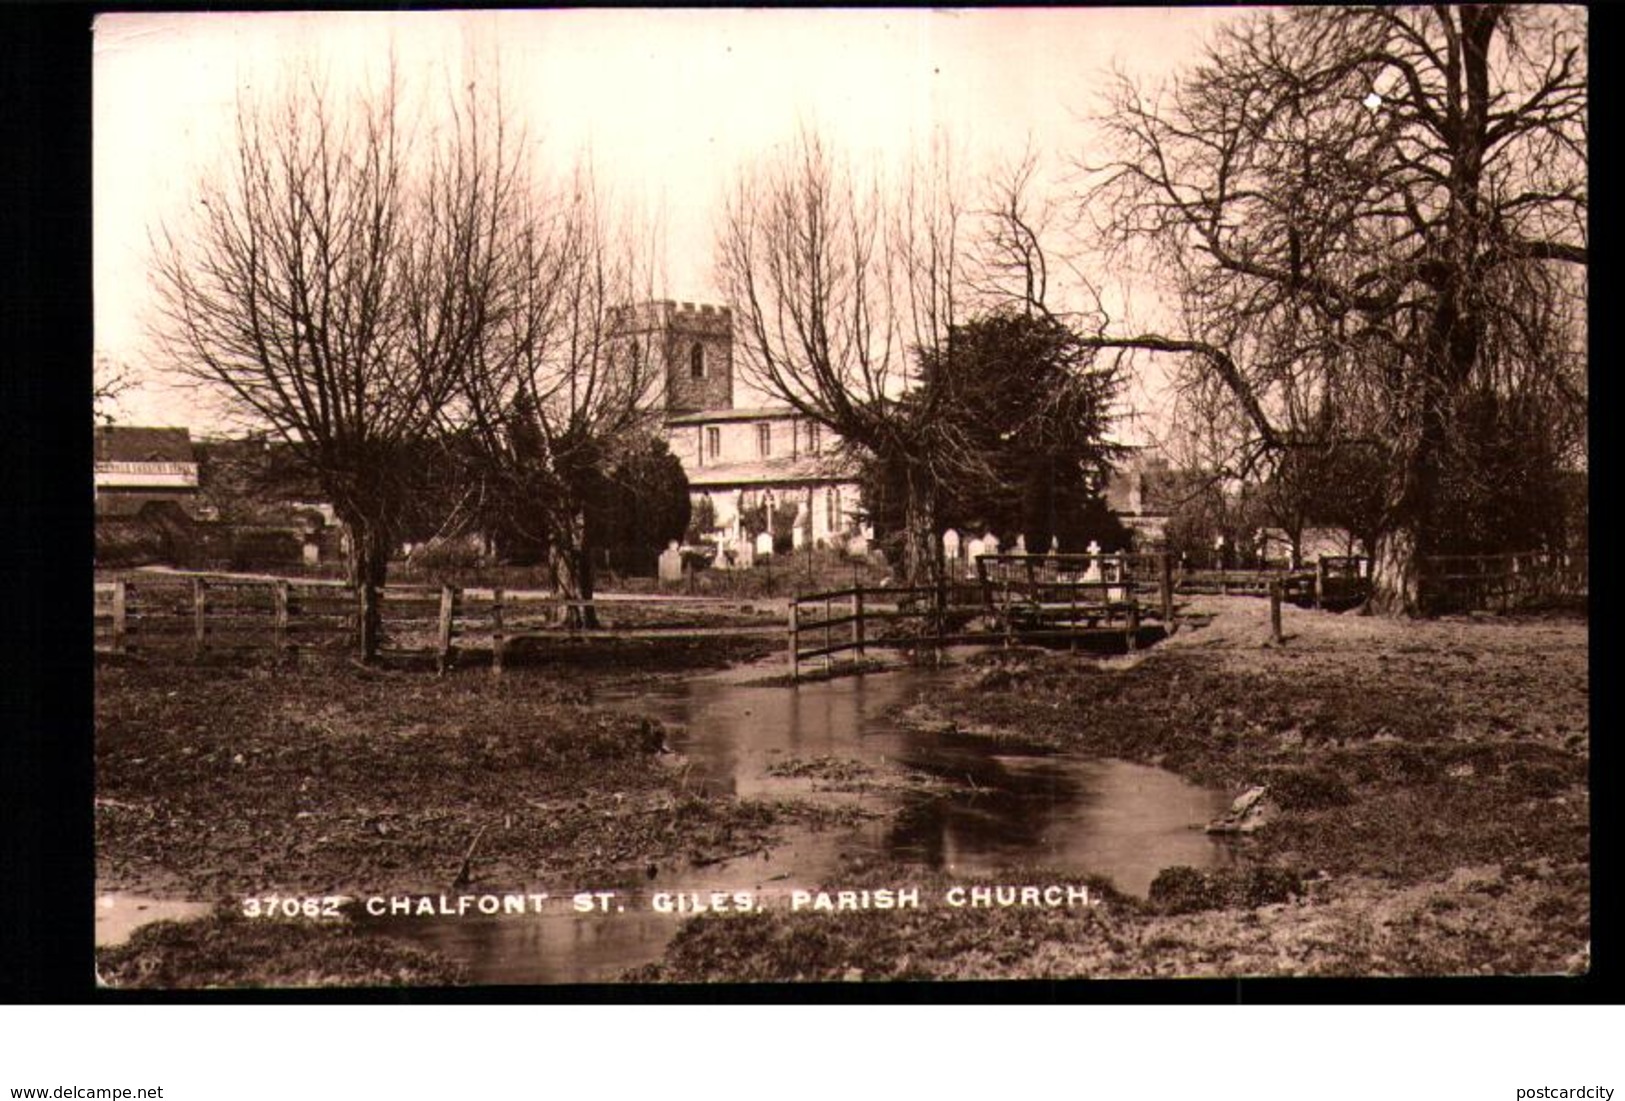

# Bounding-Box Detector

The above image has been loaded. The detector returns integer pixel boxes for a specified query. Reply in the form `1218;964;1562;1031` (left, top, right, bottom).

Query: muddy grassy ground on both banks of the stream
96;598;1591;986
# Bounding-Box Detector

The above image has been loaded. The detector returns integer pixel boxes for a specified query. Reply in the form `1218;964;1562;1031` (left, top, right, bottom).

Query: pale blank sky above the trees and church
93;8;1237;434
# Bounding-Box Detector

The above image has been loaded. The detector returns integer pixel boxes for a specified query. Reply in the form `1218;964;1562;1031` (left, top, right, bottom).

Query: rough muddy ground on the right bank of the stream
637;598;1591;981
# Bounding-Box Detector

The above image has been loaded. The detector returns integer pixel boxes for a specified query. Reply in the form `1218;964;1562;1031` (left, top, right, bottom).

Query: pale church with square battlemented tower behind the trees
621;299;861;547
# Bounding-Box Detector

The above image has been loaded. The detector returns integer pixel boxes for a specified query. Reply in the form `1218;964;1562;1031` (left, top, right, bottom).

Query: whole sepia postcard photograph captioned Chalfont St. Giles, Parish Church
92;5;1593;991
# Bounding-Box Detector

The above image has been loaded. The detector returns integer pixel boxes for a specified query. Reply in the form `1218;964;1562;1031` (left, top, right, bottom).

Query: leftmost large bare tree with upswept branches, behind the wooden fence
153;67;523;659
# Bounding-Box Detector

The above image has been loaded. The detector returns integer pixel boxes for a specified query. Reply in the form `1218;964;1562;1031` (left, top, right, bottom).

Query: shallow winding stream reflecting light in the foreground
349;669;1230;984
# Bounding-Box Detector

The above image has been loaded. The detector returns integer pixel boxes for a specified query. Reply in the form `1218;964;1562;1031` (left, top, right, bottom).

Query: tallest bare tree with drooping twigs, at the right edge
1086;5;1588;611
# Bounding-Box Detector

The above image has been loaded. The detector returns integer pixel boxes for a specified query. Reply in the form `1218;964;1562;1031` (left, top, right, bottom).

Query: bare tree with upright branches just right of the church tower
718;130;988;583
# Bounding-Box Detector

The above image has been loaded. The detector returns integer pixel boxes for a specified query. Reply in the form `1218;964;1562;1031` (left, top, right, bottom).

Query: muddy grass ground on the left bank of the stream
96;638;812;986
